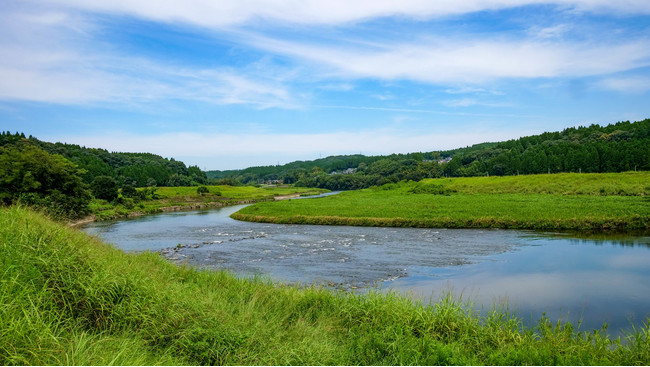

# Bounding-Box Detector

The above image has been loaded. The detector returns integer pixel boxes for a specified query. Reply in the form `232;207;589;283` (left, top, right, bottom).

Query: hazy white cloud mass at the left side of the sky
0;5;296;108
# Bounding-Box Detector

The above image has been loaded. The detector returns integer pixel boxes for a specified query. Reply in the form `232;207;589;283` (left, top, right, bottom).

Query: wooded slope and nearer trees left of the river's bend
0;132;213;218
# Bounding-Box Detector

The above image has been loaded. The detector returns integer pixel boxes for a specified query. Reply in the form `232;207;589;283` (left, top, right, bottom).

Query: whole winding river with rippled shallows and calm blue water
83;206;650;335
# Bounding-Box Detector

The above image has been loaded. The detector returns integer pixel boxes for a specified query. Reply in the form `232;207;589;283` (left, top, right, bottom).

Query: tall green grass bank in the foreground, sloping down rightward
0;207;650;365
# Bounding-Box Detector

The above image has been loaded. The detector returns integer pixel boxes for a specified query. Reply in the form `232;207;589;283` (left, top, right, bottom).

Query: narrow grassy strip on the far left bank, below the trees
85;185;329;220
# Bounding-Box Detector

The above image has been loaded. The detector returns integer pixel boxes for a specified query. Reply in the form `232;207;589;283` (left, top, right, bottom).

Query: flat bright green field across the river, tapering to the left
232;172;650;230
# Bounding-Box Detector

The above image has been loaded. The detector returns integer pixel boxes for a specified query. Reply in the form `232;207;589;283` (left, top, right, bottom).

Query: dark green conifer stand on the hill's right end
445;119;650;176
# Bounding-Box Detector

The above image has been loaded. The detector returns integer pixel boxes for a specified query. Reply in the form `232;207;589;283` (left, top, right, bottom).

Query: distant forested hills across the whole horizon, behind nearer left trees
0;119;650;190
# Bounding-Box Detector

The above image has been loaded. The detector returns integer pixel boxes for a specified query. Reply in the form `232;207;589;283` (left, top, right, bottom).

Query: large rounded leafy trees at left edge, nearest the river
0;142;91;217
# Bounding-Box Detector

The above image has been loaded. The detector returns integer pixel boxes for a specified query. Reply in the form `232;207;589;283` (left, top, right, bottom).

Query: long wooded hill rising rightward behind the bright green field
207;119;650;190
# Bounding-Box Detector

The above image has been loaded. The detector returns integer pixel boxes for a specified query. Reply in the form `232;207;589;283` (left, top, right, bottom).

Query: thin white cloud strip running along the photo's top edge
41;0;650;28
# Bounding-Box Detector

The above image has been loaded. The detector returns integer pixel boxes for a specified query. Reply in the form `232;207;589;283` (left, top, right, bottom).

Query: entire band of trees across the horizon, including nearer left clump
0;119;650;217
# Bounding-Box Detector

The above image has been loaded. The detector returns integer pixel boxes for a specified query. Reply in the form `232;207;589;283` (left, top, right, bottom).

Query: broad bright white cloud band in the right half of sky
250;34;650;84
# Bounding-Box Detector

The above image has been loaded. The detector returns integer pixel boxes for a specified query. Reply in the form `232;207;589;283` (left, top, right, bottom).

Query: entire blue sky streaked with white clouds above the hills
0;0;650;170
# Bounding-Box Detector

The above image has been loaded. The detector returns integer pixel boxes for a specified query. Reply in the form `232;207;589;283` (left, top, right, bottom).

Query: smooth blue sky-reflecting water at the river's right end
387;236;650;335
